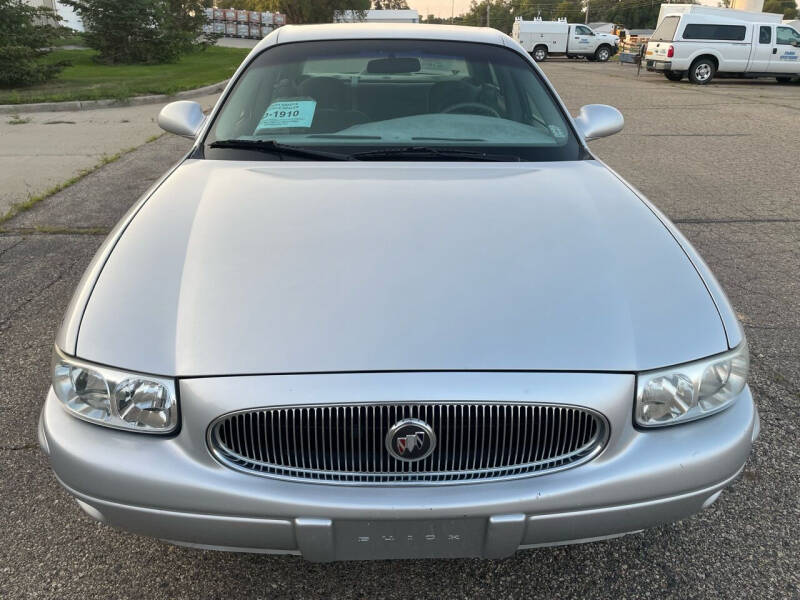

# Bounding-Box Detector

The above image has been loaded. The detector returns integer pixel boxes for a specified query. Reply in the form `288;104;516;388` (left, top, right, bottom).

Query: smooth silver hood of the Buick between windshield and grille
77;160;727;376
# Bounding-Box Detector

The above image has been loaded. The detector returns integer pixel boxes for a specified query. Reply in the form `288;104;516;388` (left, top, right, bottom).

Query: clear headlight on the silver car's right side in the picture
636;341;750;427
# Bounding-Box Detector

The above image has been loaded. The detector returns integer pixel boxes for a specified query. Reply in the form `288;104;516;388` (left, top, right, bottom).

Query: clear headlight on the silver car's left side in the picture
52;348;178;433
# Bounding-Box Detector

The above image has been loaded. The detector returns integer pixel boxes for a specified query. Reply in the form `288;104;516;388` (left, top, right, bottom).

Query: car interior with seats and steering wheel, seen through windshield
214;57;542;137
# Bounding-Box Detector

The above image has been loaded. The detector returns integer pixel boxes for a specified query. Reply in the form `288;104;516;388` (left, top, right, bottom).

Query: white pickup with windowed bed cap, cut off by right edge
645;6;800;84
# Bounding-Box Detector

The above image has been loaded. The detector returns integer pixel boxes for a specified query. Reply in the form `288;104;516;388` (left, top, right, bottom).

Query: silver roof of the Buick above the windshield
255;23;511;50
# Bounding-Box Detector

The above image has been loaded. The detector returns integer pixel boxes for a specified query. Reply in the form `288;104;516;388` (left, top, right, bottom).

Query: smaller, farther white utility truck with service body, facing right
511;17;619;62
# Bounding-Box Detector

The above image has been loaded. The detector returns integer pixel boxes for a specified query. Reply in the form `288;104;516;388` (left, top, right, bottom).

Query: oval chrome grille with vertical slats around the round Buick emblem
208;402;608;484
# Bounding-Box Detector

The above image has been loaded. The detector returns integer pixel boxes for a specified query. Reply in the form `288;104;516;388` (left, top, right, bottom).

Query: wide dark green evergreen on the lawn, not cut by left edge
62;0;214;64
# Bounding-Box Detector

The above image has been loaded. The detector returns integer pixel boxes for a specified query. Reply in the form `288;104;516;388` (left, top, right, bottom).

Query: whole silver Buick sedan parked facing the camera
39;24;759;561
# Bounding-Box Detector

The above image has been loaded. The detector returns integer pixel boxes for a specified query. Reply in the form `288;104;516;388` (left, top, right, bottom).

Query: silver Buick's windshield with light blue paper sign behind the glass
204;40;582;160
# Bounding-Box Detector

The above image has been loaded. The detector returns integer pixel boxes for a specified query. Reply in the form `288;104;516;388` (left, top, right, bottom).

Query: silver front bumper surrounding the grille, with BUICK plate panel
40;373;758;561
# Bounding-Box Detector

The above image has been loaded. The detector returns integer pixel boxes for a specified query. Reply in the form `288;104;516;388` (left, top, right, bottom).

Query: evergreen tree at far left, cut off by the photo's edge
0;0;67;87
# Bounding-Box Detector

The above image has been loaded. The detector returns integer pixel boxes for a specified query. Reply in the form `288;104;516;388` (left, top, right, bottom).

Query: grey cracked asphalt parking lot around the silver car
0;61;800;599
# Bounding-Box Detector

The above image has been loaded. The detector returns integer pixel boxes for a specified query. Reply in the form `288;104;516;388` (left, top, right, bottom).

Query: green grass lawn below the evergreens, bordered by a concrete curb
0;46;249;104
